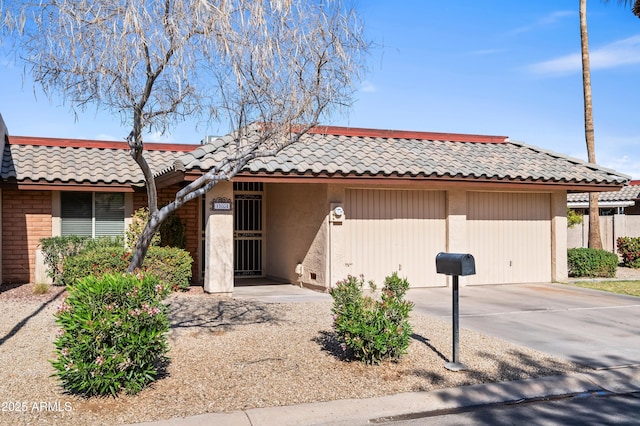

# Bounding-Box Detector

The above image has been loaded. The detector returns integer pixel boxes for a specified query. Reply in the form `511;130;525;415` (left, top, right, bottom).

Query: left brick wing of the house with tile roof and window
0;132;201;283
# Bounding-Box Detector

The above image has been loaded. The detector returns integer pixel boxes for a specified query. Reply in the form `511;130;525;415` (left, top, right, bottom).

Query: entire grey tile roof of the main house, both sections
0;127;629;190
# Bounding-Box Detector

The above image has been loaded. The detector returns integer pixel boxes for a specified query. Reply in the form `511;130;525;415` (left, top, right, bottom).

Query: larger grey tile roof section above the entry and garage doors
163;128;630;185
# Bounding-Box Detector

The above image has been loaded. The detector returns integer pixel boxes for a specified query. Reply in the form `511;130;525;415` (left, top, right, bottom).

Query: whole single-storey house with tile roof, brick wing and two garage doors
0;116;629;293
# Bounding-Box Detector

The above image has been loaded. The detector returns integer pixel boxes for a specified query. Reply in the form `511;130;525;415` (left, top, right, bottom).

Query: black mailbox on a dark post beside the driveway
436;253;476;371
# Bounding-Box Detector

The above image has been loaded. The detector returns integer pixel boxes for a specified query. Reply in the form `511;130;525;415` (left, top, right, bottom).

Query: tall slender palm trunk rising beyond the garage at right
580;0;602;249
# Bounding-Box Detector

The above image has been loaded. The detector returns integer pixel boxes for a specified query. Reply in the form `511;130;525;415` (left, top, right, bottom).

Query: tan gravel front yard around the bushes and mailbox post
0;278;608;425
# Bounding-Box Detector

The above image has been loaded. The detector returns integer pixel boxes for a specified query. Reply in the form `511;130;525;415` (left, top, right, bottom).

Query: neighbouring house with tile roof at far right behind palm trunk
567;180;640;252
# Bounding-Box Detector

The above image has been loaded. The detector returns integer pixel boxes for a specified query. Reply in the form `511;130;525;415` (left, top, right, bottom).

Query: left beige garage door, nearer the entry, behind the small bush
344;189;446;287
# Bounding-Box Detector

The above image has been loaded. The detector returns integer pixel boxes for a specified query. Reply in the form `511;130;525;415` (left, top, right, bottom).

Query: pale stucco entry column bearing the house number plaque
203;182;233;294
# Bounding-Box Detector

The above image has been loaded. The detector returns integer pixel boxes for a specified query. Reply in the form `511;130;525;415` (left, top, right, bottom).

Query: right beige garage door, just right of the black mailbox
466;192;551;284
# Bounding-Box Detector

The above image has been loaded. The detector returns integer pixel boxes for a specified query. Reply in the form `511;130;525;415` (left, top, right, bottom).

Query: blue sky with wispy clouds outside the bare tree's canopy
0;0;640;179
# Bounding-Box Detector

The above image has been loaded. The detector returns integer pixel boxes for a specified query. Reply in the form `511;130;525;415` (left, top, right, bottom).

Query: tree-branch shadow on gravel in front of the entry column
169;297;282;331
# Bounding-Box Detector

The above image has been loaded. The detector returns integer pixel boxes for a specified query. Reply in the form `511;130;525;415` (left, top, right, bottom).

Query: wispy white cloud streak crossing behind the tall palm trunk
526;35;640;75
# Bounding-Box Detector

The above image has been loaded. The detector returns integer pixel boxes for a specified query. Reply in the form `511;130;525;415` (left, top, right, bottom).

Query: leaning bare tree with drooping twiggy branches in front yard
5;0;368;271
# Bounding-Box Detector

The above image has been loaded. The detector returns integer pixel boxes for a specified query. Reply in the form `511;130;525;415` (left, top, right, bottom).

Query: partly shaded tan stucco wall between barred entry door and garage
265;184;329;287
